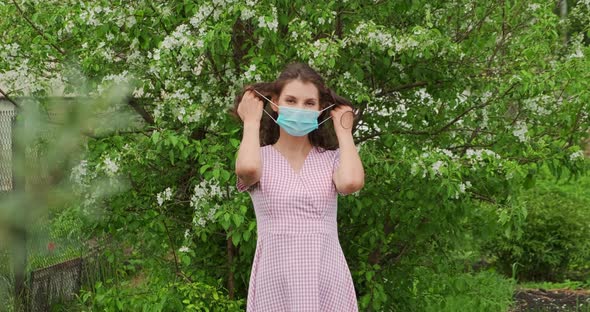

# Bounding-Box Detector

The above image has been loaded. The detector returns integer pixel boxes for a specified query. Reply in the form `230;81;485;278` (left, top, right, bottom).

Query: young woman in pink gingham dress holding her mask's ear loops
234;63;364;312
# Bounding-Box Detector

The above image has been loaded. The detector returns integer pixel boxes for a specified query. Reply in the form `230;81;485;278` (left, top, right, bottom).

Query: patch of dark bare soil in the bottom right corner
511;288;590;312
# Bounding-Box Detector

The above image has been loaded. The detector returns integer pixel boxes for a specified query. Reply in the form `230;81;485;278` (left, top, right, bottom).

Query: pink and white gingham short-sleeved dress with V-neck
237;145;358;312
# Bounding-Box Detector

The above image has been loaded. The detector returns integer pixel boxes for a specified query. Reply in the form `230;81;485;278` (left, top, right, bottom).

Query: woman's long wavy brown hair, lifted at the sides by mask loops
230;63;354;150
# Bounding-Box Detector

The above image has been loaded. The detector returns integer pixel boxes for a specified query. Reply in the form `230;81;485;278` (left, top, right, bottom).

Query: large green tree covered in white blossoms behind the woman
0;0;590;310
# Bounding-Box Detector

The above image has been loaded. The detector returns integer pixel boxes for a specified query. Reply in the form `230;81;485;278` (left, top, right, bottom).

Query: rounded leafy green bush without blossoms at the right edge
489;166;590;282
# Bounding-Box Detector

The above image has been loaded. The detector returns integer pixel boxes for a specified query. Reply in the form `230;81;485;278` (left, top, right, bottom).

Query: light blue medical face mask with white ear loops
254;90;336;136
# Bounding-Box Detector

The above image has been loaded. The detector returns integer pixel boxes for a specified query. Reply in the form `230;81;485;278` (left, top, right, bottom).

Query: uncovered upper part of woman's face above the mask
272;80;320;111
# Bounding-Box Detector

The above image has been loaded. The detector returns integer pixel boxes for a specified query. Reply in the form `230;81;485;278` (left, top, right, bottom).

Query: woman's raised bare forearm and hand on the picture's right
331;106;365;195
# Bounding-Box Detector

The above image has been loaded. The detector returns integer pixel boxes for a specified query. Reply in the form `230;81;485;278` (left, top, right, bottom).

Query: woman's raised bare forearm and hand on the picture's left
236;91;263;186
